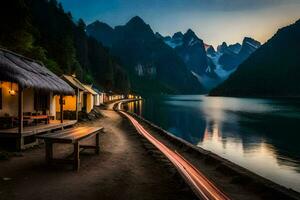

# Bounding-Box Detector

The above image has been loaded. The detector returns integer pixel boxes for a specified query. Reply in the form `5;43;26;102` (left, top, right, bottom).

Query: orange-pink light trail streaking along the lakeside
118;102;229;200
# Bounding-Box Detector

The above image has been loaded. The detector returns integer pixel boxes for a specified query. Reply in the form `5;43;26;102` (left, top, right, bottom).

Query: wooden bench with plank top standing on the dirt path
36;127;103;171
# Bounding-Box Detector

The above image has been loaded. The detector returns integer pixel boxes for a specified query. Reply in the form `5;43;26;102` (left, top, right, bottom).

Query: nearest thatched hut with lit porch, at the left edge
0;49;76;149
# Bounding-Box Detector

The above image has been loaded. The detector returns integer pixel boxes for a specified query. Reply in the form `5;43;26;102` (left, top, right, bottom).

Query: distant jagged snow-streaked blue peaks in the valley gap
162;29;260;90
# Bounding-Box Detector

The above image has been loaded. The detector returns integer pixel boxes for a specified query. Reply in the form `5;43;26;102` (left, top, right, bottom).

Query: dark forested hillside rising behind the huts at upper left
0;0;130;92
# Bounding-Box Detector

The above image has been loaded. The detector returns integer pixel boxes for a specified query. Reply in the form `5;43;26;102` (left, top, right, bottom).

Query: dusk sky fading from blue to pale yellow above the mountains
60;0;300;46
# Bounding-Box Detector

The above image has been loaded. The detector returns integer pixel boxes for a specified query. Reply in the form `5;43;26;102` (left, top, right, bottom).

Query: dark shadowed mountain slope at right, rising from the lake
210;20;300;97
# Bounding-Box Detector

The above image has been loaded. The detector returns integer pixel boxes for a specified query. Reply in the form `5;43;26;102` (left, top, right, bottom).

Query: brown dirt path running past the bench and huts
0;105;196;200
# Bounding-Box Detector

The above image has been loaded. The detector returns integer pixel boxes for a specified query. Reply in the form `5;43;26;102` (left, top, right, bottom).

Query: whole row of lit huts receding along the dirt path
0;49;125;148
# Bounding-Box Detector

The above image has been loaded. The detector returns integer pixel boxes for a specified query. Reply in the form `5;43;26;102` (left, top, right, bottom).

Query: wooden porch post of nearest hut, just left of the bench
16;86;23;151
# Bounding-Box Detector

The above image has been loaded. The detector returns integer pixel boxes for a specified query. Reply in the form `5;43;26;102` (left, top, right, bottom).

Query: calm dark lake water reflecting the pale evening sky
125;95;300;192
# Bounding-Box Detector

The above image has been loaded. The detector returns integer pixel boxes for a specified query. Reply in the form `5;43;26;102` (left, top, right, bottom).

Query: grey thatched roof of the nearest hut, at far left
0;49;74;95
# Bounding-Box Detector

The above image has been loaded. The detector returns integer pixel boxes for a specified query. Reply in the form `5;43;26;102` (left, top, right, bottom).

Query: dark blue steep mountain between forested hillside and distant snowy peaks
87;16;204;93
